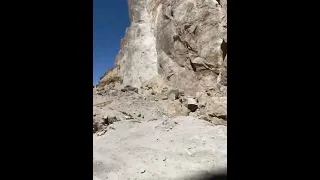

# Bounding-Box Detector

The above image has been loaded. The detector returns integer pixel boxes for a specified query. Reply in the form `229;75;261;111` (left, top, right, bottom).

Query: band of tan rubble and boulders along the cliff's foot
93;77;227;132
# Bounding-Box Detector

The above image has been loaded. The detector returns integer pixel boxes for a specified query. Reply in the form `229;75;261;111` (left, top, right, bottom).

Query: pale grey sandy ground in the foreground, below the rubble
93;116;227;180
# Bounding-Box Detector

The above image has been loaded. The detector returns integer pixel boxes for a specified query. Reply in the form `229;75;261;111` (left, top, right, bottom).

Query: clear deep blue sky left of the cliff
93;0;130;84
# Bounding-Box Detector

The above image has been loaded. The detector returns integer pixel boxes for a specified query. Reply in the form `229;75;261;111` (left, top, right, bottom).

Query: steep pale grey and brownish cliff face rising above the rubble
99;0;227;96
